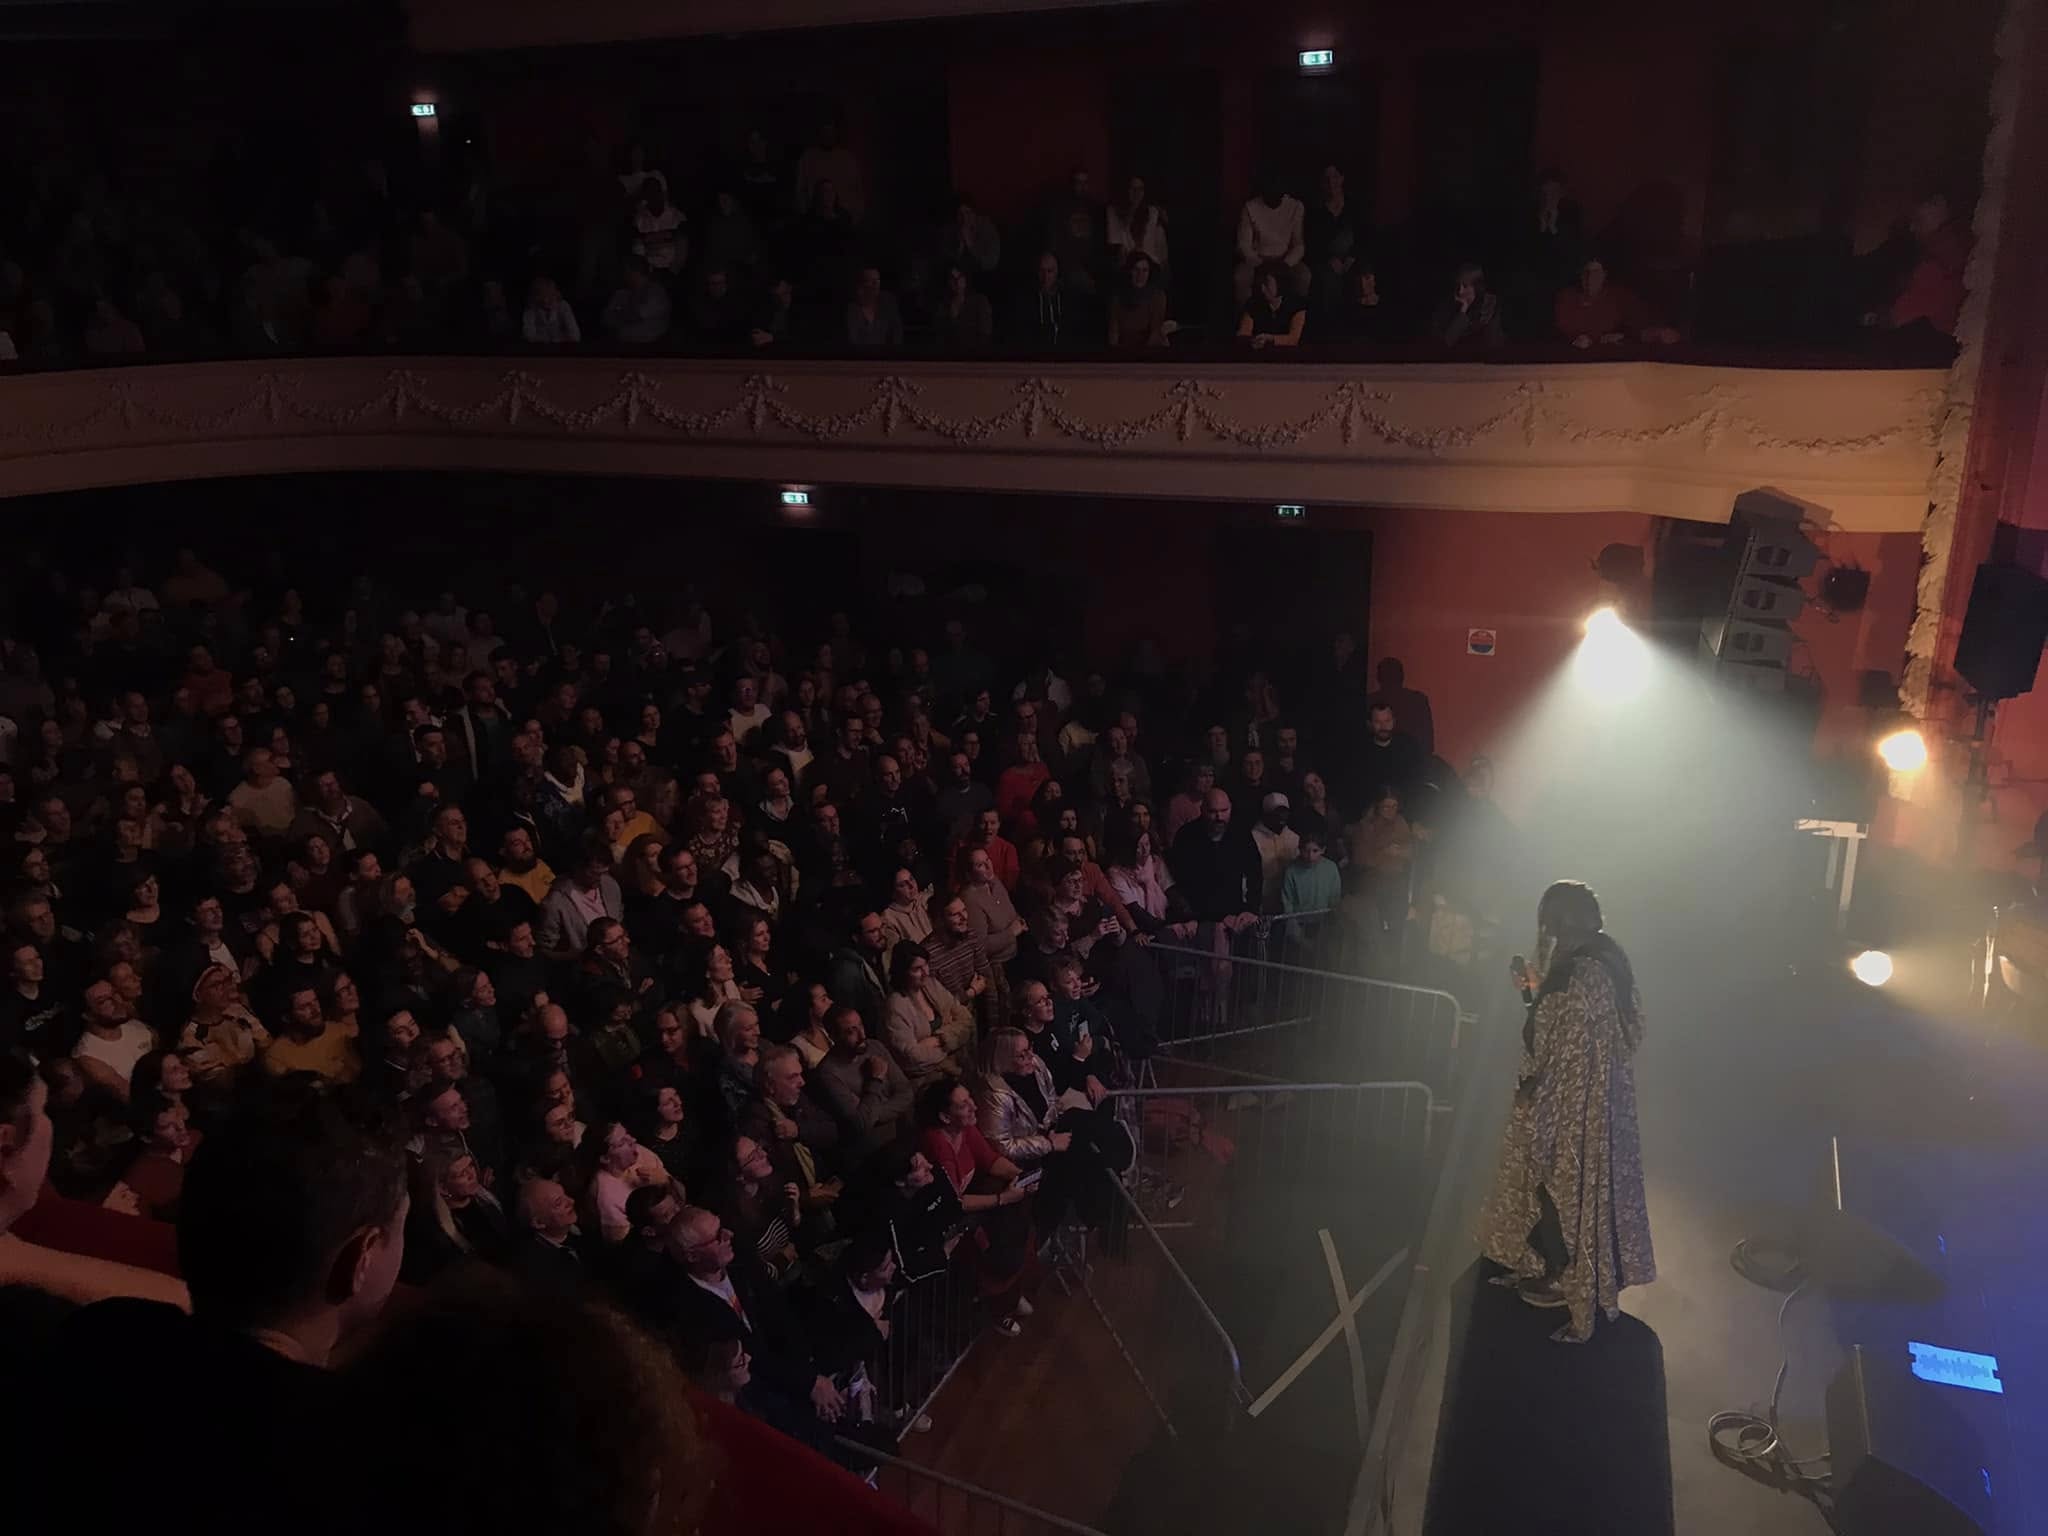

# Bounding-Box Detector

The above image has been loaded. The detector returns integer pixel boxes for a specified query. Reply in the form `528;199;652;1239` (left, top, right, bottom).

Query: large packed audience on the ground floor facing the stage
0;551;1501;1531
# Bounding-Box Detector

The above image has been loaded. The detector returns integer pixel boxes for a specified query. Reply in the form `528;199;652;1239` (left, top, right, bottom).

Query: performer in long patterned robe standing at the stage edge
1481;881;1657;1343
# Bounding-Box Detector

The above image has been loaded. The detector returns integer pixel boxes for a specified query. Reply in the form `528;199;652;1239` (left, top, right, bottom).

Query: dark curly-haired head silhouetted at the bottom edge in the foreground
339;1274;717;1536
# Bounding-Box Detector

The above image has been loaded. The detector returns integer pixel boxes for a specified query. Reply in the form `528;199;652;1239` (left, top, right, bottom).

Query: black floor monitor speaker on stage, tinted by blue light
1827;1343;1991;1536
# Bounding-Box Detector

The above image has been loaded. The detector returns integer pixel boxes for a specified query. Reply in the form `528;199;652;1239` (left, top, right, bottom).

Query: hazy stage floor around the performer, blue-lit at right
1395;954;2048;1536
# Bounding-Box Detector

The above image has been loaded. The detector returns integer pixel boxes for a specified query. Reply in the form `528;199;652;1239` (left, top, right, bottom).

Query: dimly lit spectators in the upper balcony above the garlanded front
0;102;1968;367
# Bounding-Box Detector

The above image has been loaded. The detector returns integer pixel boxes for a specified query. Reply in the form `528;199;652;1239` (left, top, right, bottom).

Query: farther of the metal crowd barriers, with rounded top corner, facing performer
1149;930;1462;1104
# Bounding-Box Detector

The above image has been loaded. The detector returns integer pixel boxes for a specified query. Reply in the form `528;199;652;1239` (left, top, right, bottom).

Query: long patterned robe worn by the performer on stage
1479;956;1657;1343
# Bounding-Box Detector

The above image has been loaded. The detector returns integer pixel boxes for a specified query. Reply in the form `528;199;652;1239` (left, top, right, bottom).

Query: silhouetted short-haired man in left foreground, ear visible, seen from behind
19;1092;408;1536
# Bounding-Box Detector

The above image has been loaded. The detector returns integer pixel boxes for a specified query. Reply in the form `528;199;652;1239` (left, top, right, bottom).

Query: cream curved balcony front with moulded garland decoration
0;352;1946;532
